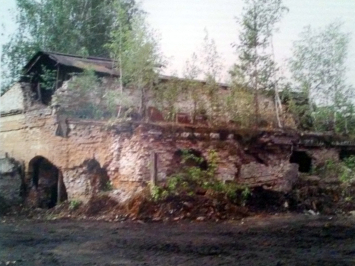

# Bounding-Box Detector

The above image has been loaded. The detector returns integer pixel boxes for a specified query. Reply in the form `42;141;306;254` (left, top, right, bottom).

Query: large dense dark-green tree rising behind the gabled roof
2;0;137;90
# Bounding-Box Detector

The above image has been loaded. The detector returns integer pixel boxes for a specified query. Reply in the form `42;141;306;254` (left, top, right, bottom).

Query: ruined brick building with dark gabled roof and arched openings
0;52;354;207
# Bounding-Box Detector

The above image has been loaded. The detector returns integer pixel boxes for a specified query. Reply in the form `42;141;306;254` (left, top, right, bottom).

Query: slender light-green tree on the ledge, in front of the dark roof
107;0;163;117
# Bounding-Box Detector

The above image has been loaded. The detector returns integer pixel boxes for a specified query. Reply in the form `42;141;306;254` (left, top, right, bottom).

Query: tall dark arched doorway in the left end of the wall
29;156;68;208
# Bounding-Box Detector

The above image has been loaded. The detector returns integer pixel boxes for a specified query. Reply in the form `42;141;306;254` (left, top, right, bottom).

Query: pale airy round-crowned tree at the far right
289;23;351;130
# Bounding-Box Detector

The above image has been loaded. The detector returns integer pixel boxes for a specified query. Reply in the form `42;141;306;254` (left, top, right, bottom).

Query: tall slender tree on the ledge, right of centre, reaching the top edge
231;0;287;126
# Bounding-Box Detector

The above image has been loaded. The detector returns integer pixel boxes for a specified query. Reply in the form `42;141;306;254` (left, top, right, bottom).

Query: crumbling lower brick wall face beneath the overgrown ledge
0;108;354;205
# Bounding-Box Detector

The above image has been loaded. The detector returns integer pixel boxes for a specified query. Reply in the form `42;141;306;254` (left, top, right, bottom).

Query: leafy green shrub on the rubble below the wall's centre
151;150;250;205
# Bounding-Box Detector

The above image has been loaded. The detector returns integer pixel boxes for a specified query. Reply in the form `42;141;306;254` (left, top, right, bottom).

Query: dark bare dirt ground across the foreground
0;214;355;266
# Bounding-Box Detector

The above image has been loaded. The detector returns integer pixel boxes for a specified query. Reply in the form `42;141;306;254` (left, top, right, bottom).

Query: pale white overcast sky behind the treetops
0;0;355;86
